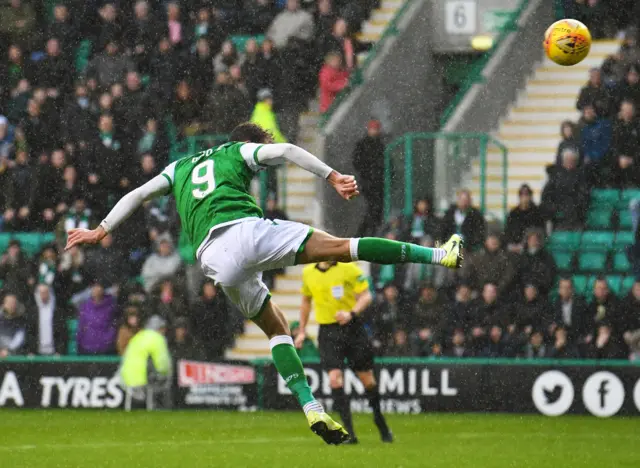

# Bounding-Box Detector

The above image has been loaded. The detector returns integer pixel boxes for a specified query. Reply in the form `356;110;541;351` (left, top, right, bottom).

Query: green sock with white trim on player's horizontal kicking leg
351;237;446;265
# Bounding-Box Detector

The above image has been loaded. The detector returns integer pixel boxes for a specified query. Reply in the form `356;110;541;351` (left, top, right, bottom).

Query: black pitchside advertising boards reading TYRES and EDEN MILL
0;358;640;417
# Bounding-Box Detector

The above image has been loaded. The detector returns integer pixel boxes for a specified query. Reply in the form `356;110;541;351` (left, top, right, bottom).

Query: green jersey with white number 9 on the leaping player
162;142;262;255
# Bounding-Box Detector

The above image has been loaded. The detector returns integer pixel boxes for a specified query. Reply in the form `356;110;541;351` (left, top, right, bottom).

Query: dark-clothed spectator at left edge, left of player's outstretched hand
4;151;36;231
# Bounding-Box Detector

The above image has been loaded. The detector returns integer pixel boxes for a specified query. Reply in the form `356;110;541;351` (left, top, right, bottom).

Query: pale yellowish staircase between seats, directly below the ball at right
469;40;620;219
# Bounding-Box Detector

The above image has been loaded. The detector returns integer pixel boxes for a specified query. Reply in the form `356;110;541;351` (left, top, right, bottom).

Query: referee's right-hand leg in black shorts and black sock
347;323;393;442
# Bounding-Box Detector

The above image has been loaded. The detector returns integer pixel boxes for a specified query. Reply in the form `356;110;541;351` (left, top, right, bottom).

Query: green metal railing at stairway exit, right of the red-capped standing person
384;133;509;219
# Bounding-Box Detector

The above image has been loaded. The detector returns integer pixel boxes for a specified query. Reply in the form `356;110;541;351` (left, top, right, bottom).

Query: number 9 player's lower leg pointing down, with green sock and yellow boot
251;296;349;445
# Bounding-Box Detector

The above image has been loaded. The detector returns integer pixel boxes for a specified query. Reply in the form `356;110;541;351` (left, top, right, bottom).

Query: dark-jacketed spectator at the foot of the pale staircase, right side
504;184;544;253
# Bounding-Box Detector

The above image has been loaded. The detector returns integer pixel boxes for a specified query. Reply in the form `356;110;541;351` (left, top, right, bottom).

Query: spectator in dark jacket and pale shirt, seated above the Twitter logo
549;278;589;342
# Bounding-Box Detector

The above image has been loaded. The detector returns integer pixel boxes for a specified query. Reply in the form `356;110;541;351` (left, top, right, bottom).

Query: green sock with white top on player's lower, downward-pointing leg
269;335;324;413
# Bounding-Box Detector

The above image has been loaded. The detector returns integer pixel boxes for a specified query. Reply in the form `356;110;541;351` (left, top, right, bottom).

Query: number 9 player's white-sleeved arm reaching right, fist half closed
253;143;360;200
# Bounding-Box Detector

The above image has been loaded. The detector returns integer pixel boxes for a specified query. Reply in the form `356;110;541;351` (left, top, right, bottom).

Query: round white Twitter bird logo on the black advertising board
531;370;575;416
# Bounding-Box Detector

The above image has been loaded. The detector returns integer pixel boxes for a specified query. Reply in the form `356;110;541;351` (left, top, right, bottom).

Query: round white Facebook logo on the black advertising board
582;371;624;418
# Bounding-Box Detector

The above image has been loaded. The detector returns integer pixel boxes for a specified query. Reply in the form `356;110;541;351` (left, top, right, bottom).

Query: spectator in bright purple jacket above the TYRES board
77;281;117;354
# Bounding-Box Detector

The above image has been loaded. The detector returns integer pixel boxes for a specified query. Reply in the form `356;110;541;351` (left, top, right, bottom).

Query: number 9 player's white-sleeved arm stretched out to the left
65;175;171;250
